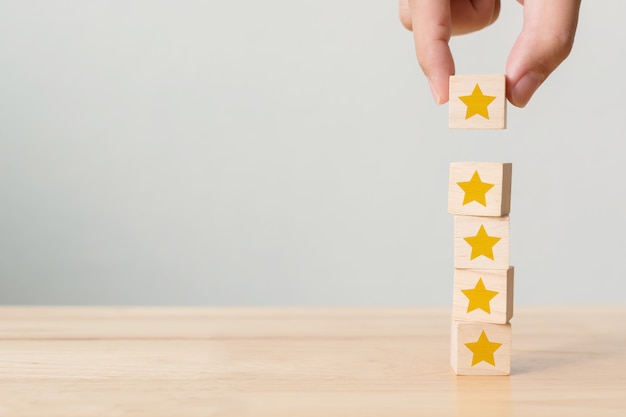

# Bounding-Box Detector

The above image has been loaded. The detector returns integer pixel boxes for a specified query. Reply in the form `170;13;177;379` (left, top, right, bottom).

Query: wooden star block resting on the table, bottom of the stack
450;321;511;375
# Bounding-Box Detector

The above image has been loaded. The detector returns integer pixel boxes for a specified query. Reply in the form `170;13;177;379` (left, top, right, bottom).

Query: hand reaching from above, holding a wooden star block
400;0;581;107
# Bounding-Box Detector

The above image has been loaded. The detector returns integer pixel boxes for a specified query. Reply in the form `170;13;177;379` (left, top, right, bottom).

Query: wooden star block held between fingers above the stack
449;74;506;129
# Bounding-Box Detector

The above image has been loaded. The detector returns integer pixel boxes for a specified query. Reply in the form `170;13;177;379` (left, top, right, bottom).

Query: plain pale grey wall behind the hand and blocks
0;0;626;305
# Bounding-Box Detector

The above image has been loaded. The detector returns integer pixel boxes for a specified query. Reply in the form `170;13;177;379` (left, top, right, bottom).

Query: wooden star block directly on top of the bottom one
452;267;514;324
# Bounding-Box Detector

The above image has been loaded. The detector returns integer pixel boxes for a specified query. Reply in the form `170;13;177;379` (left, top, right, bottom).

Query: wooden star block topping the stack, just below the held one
448;162;513;217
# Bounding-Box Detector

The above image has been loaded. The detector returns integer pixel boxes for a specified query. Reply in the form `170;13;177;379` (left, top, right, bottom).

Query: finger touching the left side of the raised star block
409;0;454;104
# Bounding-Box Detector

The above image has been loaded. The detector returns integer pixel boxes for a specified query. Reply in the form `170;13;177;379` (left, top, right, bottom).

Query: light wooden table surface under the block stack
0;307;626;417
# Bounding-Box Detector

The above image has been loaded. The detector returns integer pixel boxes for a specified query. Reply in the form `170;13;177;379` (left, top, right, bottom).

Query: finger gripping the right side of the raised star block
506;0;581;107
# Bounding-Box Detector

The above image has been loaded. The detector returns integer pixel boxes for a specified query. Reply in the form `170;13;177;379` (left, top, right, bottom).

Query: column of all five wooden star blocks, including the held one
448;75;513;375
